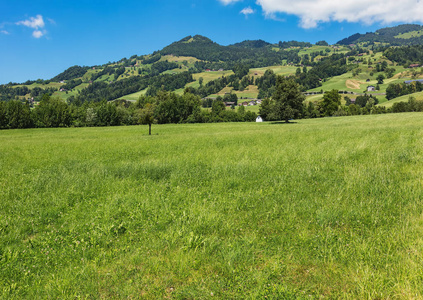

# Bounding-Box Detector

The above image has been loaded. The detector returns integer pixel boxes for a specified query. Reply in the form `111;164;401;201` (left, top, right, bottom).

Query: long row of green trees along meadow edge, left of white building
0;91;257;129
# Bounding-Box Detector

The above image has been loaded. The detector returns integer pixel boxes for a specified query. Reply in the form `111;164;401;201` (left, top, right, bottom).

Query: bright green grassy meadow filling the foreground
0;113;423;299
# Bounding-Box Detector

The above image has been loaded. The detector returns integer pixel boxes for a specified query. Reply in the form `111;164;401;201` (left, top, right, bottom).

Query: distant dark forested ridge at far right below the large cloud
337;24;423;46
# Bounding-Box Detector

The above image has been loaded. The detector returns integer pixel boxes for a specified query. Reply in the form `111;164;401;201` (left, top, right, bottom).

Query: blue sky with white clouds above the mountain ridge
0;0;423;84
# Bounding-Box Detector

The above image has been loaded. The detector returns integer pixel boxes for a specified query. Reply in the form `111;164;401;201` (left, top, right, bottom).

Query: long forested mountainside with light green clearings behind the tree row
5;25;423;104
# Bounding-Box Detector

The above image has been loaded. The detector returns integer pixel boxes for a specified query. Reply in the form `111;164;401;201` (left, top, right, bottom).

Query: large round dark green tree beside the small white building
272;76;305;123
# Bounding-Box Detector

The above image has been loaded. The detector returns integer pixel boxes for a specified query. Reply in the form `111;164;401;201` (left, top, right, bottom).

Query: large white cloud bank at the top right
255;0;423;28
